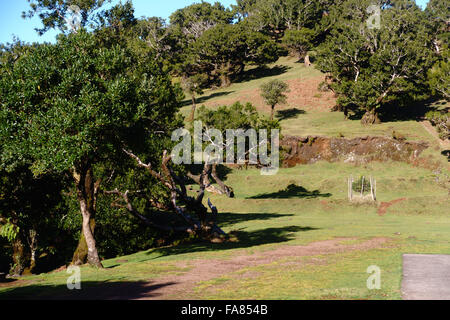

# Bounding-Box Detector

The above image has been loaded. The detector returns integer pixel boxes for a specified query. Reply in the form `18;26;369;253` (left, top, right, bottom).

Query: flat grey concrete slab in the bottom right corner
402;254;450;300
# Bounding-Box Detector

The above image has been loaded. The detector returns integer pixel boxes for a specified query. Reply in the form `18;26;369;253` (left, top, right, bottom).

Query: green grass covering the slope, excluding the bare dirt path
0;59;450;299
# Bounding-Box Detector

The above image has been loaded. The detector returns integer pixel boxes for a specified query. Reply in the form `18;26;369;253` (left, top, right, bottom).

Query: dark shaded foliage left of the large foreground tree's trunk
0;167;77;270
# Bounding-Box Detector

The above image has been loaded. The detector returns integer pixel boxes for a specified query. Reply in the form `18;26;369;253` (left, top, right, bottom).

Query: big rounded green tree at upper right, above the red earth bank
317;0;433;124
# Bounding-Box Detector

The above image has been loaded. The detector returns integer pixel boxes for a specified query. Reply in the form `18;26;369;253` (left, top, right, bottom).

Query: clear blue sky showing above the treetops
0;0;428;43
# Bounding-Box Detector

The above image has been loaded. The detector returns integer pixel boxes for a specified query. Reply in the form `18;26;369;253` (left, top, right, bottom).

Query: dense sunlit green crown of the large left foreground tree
0;32;182;173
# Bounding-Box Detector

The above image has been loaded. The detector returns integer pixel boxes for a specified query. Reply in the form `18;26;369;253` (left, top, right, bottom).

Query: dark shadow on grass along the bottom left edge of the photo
0;281;175;301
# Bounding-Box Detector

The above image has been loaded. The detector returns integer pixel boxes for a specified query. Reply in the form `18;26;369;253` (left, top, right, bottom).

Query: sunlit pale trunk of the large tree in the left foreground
72;164;103;268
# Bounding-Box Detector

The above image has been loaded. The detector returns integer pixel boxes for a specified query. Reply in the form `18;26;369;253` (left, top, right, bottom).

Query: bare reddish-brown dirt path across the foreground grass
113;238;390;300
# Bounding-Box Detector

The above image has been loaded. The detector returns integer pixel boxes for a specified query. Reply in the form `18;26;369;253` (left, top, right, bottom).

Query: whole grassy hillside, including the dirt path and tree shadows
0;58;450;299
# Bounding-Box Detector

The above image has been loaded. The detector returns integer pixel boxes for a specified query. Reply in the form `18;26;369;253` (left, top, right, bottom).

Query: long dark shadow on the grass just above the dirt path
148;226;319;260
